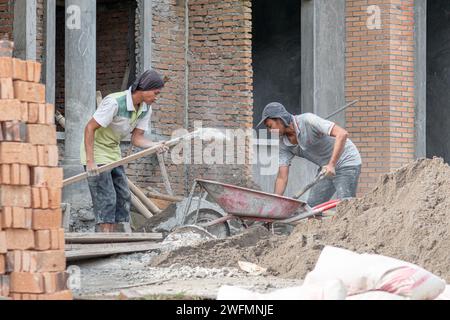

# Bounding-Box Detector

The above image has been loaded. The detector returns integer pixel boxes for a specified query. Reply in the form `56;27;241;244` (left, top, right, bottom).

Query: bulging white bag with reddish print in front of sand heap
305;247;445;300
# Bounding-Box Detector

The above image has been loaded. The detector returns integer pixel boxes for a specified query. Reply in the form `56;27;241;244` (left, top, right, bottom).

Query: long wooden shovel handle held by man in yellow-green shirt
63;130;202;186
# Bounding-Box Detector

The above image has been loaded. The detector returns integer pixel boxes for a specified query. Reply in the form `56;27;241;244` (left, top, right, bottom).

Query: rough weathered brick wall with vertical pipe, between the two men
127;0;253;194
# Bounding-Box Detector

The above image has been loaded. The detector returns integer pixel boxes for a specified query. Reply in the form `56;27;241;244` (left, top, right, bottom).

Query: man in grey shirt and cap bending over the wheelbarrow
258;102;361;207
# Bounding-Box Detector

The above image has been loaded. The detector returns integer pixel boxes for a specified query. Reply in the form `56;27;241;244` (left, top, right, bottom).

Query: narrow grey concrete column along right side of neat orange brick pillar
414;0;427;158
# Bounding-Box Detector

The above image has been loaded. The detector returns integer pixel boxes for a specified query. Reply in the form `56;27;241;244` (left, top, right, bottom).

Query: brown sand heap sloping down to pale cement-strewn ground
74;159;450;297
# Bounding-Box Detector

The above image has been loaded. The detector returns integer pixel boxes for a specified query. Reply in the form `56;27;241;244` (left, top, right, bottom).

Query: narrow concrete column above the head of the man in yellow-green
138;0;153;73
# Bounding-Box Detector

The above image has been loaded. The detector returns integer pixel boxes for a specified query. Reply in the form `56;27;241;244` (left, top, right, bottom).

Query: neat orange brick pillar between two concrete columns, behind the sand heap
346;0;415;194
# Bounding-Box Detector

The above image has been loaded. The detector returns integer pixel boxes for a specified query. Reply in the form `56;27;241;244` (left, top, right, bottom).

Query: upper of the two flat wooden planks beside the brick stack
65;233;163;244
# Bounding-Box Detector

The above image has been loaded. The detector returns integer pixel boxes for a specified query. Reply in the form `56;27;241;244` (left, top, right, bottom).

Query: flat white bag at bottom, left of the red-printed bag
217;280;347;300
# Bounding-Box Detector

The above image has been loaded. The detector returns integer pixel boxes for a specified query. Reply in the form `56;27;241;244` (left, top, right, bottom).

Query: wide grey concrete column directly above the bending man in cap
301;0;345;126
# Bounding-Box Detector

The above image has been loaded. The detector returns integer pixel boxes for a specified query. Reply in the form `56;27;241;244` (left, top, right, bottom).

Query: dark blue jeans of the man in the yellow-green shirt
88;166;131;224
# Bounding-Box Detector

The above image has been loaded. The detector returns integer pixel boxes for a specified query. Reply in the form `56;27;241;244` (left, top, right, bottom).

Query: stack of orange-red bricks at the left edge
0;57;72;300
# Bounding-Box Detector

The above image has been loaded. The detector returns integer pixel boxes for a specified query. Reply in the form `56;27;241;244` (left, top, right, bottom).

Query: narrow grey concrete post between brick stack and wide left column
43;0;56;104
